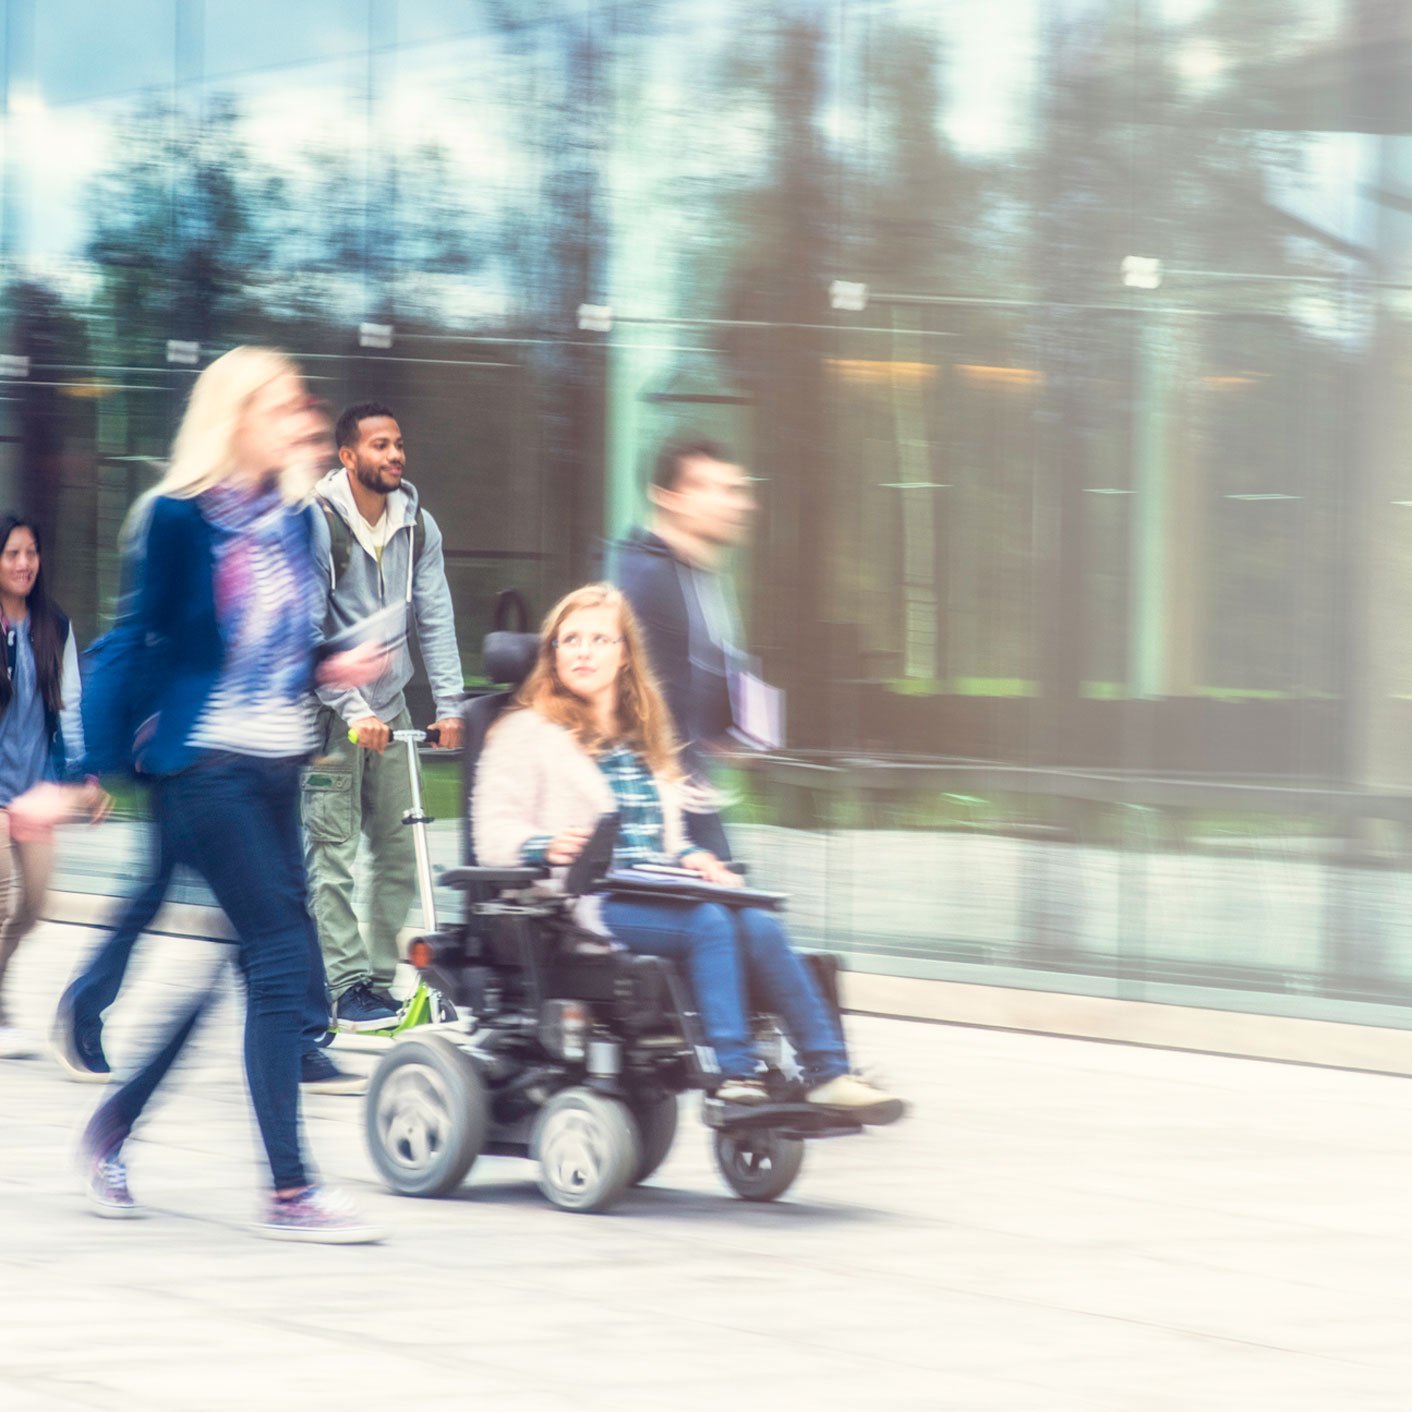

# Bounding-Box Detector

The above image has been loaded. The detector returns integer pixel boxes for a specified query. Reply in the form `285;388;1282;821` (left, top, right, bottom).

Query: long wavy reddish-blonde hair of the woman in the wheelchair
515;583;682;781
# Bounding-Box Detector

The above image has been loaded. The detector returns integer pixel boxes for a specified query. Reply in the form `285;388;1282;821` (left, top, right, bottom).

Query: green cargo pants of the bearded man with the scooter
301;707;417;1000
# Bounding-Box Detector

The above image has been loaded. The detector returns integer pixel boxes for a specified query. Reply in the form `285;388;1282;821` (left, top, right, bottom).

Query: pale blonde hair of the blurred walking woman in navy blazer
154;346;308;504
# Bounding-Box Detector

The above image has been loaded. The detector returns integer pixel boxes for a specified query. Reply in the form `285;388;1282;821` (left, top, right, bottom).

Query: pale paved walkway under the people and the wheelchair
0;925;1412;1412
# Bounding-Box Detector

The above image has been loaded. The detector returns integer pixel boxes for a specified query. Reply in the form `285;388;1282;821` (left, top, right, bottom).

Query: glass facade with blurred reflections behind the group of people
0;0;1412;1027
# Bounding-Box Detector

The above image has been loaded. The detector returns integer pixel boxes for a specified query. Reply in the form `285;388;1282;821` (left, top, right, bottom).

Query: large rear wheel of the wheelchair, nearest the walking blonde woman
363;1035;490;1196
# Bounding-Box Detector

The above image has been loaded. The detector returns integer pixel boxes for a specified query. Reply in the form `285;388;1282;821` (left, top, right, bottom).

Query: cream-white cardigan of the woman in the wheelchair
472;707;686;868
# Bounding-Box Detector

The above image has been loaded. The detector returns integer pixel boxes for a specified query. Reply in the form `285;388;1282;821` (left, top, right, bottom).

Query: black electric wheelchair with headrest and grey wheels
364;607;892;1211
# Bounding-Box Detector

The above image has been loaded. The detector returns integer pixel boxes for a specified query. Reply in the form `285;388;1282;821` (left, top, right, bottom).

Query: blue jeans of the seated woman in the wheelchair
603;897;849;1087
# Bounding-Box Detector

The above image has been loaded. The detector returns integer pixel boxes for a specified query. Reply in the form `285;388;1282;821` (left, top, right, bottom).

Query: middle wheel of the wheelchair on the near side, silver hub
530;1089;641;1211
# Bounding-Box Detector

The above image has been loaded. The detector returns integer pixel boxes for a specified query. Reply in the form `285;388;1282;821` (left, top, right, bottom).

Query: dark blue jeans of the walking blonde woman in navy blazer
88;754;318;1190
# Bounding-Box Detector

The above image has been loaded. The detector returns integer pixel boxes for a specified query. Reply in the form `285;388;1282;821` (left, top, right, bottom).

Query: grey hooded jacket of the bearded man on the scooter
313;466;466;724
